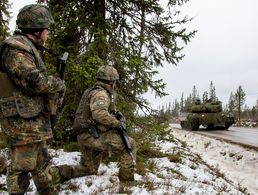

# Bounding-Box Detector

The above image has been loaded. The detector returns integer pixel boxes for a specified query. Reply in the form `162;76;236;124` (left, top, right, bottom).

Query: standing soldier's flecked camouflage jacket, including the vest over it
0;35;65;144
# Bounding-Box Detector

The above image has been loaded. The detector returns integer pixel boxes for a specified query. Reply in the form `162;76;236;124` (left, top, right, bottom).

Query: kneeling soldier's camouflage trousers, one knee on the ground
58;131;136;181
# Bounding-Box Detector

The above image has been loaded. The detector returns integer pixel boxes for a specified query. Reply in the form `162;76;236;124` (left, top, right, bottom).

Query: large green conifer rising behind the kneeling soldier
39;0;195;130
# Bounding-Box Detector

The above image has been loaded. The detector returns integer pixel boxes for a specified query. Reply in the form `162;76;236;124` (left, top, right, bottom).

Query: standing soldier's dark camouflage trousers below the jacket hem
7;142;55;195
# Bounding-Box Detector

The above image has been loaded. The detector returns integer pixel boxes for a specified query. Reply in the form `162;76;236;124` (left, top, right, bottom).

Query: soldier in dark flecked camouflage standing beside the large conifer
0;4;65;195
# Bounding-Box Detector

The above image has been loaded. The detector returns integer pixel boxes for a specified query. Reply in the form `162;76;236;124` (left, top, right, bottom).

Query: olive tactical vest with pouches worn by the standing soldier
0;35;46;118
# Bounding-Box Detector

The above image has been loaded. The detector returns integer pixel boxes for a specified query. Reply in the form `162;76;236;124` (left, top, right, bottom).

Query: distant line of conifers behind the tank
159;81;258;121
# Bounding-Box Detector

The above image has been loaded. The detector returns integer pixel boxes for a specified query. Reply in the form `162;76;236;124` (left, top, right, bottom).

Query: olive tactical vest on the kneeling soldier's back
72;86;104;130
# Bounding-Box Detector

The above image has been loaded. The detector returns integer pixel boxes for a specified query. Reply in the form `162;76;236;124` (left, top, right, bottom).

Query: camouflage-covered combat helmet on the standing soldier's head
16;4;54;29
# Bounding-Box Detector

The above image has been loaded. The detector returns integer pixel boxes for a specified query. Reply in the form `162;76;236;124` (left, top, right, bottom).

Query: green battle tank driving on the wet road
180;101;235;131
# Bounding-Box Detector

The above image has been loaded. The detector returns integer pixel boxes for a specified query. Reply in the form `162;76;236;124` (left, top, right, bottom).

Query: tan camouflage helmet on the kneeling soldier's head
96;65;119;82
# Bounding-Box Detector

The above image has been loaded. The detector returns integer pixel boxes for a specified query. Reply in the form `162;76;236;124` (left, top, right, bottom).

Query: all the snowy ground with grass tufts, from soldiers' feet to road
0;125;258;195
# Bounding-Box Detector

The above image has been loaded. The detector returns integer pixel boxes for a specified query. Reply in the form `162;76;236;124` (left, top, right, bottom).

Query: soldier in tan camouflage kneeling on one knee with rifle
54;66;136;181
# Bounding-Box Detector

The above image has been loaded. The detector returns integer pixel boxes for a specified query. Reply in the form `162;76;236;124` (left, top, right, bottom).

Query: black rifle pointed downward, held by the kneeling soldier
112;111;136;166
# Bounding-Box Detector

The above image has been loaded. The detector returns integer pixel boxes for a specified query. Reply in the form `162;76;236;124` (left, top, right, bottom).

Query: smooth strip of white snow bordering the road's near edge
169;125;258;195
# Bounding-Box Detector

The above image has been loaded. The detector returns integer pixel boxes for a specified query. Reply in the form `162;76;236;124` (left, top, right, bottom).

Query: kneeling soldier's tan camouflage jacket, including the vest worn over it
74;82;119;132
